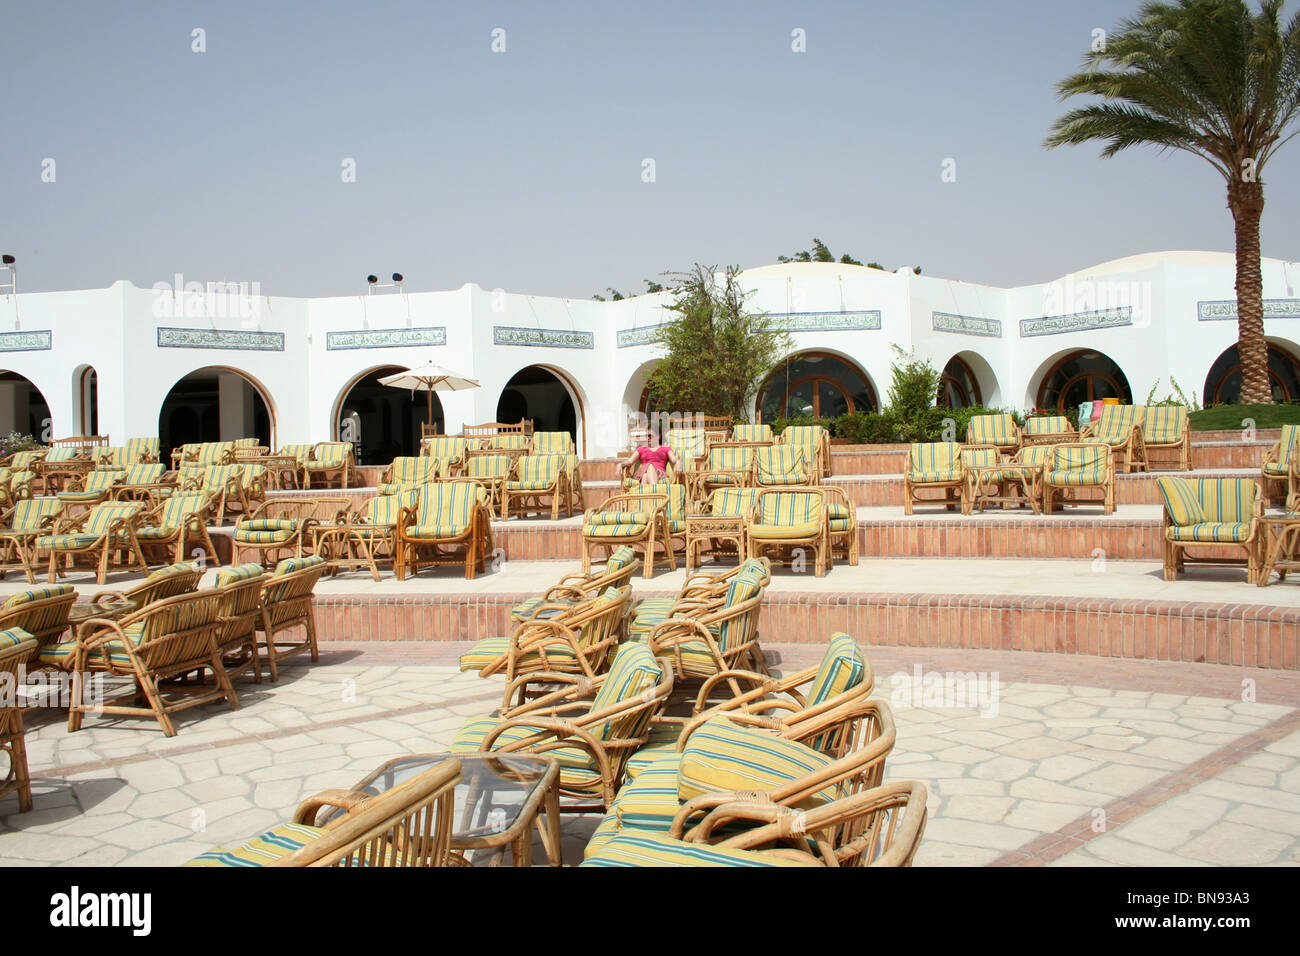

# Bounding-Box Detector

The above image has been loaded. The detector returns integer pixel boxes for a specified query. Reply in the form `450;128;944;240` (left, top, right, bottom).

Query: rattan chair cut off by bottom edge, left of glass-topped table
185;760;460;868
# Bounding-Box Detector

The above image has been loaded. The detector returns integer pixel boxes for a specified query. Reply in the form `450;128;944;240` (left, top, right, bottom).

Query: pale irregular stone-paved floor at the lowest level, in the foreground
0;643;1300;866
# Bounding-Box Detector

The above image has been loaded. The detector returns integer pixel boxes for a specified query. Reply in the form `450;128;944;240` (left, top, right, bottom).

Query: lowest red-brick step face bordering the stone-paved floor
315;579;1300;683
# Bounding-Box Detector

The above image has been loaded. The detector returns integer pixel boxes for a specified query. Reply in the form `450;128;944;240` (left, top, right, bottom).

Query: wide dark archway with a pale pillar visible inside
159;365;276;462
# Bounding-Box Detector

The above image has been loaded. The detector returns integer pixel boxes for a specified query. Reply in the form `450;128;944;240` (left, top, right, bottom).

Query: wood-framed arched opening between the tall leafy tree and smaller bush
758;351;876;421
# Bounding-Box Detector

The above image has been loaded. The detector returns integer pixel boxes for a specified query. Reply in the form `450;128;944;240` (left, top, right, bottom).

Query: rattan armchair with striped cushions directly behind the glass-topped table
451;644;672;813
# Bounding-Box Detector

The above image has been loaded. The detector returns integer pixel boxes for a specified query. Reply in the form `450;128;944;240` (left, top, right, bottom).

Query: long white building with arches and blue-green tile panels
0;251;1300;464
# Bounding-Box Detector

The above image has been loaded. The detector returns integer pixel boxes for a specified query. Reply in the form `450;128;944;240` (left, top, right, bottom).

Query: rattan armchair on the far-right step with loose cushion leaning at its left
1156;476;1264;583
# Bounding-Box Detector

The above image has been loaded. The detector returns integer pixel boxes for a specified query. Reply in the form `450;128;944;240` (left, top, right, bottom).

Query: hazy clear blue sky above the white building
0;0;1300;298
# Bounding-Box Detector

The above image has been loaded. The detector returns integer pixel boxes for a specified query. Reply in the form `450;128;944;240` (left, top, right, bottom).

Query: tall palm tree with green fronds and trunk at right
1044;0;1300;405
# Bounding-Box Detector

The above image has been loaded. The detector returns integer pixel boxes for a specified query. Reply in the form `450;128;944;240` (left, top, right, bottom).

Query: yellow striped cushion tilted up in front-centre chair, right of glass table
677;717;839;806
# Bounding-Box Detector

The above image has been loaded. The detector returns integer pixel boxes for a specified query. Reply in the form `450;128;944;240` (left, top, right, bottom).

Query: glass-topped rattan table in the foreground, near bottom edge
317;753;564;866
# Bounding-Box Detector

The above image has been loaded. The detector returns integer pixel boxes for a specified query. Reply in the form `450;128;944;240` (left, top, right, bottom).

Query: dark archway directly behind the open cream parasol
332;365;446;464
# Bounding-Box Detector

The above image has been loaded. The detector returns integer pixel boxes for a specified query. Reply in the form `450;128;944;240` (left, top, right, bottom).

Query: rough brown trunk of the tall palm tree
1227;179;1273;405
